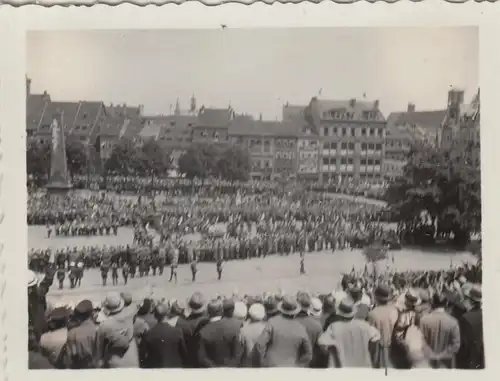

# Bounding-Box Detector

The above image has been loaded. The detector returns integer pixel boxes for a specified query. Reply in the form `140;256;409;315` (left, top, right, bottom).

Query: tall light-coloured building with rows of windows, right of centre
305;97;385;181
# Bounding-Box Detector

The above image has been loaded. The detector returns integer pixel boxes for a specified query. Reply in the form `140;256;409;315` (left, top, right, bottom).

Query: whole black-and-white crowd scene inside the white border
23;24;485;372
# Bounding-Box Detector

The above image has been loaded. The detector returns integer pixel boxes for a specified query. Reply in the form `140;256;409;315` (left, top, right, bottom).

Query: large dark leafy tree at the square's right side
386;142;481;246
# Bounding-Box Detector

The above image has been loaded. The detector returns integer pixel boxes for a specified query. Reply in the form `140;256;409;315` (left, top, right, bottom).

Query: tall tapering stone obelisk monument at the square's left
46;110;73;195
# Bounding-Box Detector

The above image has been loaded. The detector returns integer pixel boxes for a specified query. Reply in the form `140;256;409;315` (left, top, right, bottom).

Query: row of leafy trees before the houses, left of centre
26;140;250;180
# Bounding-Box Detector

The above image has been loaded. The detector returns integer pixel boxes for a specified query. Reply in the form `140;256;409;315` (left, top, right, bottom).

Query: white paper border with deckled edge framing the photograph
0;0;500;381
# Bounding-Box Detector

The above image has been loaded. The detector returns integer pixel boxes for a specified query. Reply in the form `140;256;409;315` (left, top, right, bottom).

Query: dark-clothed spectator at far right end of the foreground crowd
457;284;484;369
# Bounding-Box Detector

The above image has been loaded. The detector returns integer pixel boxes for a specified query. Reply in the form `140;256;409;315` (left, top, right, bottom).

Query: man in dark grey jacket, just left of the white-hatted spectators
198;300;242;368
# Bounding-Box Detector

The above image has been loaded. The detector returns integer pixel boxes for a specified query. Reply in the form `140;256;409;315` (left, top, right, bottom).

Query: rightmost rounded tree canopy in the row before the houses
179;144;250;181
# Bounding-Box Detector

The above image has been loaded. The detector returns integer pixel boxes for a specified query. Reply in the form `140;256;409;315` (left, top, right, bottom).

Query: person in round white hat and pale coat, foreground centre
240;303;266;368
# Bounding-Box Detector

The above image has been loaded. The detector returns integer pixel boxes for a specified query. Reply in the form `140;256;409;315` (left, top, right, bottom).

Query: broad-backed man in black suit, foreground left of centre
139;304;187;368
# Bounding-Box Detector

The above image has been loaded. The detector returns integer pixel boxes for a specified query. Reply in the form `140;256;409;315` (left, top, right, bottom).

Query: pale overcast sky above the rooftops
27;27;479;119
